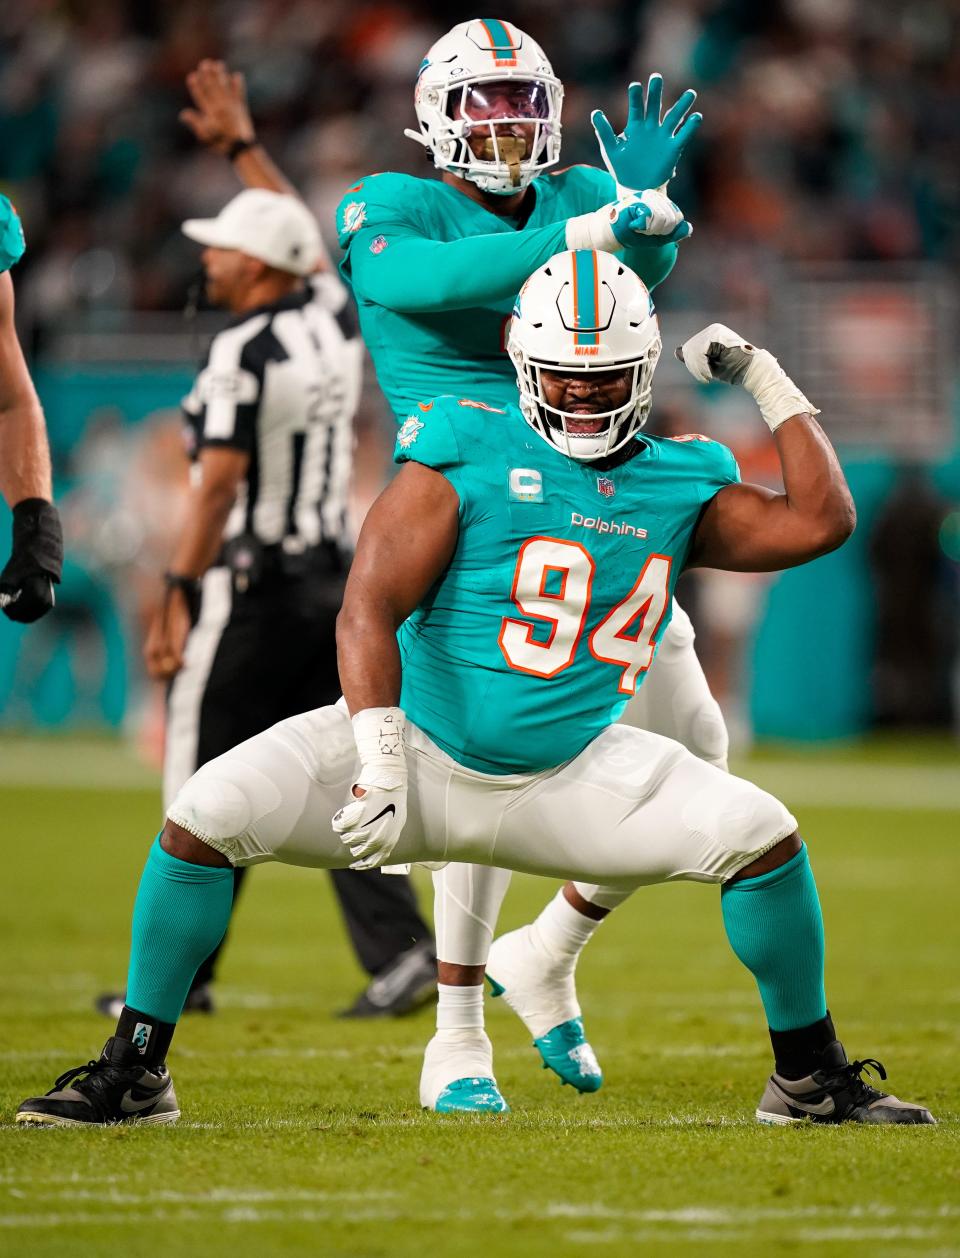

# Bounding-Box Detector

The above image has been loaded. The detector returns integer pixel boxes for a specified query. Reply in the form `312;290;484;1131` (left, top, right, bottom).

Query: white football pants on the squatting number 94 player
167;703;796;895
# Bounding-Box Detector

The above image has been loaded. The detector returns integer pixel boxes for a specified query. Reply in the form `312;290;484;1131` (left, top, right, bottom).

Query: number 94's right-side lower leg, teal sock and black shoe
721;834;935;1123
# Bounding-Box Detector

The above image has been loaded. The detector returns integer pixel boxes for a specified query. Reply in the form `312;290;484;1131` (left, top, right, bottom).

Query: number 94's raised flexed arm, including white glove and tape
677;323;857;572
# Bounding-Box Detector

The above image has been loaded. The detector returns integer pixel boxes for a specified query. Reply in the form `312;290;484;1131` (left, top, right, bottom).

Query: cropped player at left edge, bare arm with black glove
0;195;63;623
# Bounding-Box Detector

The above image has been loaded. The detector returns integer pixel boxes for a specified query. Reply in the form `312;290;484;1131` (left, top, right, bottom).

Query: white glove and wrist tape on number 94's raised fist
677;323;820;433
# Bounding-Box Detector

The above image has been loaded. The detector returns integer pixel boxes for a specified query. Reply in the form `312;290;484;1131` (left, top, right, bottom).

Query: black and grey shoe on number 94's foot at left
16;1035;180;1127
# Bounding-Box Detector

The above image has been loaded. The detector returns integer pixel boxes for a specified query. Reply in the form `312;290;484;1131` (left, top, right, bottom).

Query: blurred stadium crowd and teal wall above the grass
0;0;960;743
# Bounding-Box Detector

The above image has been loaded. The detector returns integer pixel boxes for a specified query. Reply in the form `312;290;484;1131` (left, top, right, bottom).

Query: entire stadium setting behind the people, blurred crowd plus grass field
0;0;960;1258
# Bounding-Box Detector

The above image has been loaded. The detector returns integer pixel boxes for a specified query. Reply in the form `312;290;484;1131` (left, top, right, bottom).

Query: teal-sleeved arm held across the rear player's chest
347;223;566;313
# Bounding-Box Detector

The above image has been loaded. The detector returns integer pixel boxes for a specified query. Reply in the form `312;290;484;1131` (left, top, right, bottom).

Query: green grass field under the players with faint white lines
0;741;960;1258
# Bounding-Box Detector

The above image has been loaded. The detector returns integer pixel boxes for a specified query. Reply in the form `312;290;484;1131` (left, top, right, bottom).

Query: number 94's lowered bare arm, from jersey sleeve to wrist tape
337;463;459;715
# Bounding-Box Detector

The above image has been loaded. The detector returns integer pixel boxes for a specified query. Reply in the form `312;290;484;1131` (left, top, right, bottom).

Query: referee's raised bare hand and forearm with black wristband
180;59;299;196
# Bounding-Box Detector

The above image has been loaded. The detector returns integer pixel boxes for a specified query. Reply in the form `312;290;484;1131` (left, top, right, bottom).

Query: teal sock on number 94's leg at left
126;835;233;1023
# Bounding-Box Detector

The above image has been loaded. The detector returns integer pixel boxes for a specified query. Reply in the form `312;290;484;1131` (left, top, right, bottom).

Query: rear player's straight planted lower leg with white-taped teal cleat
420;864;511;1113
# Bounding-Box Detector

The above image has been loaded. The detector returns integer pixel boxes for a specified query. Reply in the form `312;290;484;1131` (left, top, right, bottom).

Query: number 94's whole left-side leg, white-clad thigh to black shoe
16;708;356;1126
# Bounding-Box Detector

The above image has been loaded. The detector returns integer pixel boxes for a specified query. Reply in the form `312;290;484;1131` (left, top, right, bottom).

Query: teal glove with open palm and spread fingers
590;74;703;192
